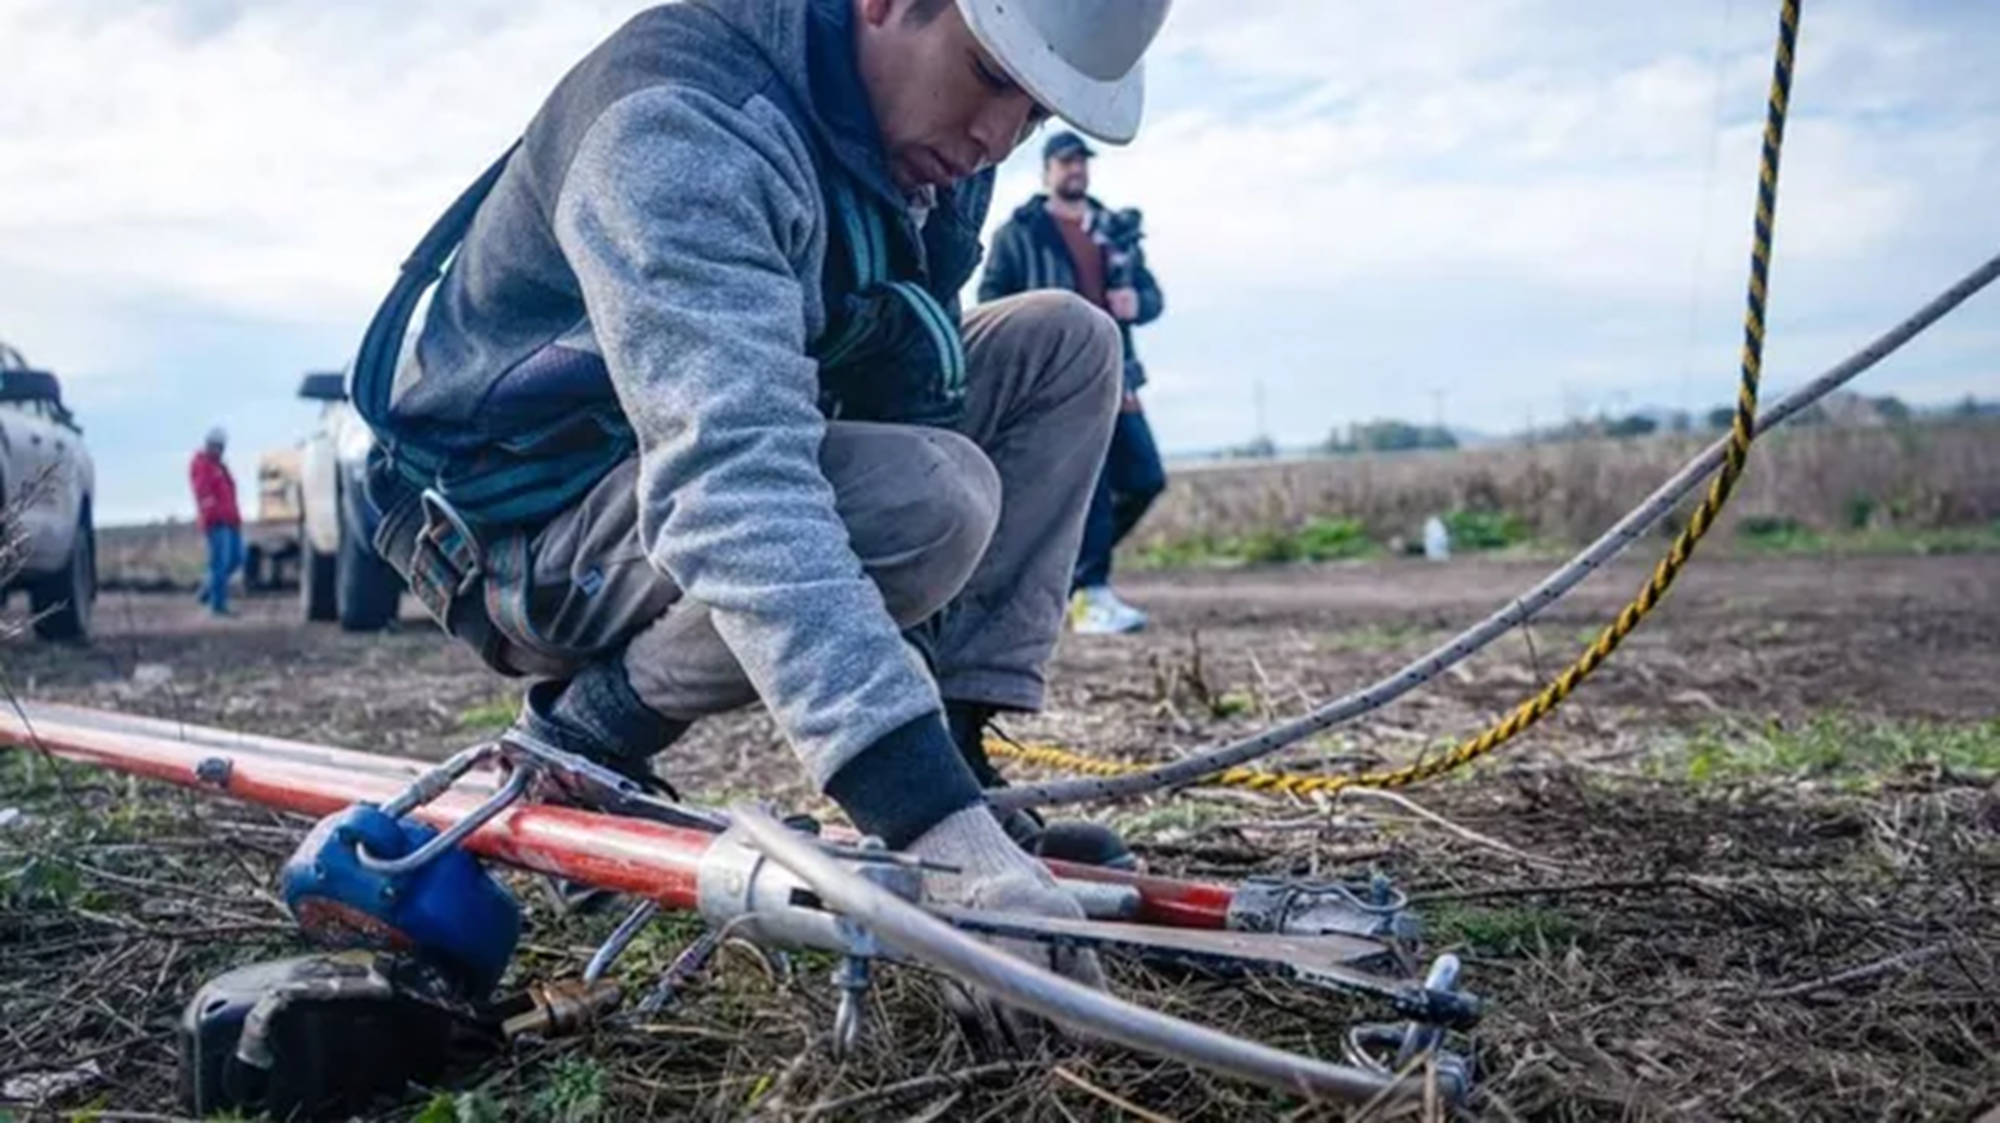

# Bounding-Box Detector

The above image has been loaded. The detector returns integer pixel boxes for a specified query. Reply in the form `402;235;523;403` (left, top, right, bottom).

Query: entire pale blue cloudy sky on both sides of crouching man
0;0;2000;522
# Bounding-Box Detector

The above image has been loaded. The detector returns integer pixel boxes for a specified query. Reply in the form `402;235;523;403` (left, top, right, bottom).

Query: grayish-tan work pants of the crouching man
508;292;1120;721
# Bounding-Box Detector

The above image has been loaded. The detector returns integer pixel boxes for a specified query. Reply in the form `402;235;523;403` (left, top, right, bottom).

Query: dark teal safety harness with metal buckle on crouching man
352;142;966;673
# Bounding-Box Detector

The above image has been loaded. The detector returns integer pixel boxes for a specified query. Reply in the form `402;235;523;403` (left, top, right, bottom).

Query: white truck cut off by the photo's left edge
0;344;98;639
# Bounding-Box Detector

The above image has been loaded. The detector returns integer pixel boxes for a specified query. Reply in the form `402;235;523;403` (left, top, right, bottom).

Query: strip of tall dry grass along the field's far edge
1132;422;2000;550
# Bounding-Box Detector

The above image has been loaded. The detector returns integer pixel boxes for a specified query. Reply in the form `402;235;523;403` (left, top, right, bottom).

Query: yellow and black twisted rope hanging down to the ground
986;0;1800;795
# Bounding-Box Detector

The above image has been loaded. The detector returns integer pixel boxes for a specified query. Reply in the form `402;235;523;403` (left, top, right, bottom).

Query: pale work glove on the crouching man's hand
908;803;1106;1049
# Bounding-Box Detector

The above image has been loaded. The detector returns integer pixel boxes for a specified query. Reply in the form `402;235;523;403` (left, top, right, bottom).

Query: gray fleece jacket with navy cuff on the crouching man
378;0;992;843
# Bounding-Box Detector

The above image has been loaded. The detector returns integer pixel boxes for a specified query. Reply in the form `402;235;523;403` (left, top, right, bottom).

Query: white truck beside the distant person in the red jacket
298;372;402;631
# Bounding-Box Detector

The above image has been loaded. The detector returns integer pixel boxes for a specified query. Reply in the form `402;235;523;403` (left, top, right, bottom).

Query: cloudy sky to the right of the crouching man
1004;2;2000;448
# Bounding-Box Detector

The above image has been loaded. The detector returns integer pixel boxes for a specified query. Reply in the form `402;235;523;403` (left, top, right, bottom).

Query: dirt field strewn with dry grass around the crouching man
0;554;2000;1119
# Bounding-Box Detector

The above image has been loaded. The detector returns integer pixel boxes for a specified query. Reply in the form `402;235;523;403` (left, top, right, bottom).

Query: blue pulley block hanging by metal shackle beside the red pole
280;803;520;1001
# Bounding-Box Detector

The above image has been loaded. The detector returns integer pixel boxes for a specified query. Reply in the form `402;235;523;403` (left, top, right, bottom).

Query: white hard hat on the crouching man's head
958;0;1174;144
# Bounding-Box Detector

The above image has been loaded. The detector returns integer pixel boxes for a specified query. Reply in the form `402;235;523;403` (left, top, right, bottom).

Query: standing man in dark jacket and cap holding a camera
980;132;1166;635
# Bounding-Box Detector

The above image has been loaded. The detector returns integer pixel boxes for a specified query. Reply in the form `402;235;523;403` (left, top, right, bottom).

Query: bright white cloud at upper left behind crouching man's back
0;0;644;331
